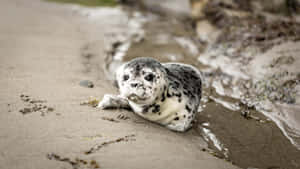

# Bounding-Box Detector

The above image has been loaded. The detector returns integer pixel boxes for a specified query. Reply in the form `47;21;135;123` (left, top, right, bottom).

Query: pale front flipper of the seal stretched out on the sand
97;94;130;109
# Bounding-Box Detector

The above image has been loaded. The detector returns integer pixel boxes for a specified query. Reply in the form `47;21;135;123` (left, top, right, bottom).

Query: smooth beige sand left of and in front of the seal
0;0;237;169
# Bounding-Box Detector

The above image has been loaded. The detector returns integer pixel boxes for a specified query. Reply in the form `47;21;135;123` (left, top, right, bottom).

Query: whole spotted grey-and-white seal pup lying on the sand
98;58;201;131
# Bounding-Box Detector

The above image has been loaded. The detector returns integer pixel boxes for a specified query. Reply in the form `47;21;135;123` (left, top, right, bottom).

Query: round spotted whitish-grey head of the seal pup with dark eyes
116;58;167;105
